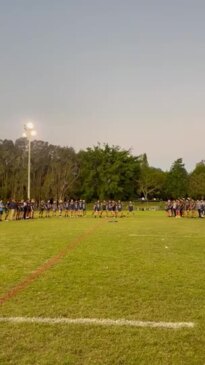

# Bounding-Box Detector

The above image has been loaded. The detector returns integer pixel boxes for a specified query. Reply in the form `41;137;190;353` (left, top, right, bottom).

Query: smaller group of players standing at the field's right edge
165;198;205;218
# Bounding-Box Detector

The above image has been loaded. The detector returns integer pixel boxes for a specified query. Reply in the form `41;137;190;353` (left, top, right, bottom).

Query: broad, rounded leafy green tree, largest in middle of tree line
79;144;139;200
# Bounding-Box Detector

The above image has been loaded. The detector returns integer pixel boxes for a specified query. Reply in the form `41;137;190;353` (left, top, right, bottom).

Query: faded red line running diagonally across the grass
0;221;103;304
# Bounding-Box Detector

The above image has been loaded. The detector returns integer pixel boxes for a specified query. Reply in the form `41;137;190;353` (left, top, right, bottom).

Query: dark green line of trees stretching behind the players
0;138;205;201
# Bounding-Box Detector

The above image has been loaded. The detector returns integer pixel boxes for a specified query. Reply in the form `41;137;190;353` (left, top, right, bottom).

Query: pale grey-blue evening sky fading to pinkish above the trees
0;0;205;171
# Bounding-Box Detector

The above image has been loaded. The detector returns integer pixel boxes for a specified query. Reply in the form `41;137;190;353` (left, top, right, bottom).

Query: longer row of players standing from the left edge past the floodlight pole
0;199;134;221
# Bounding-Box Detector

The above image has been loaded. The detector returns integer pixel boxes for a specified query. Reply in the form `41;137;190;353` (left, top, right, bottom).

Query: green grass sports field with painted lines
0;212;205;365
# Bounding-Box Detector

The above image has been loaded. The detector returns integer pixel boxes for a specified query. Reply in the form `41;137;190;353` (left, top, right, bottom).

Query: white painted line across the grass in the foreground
0;317;194;329
